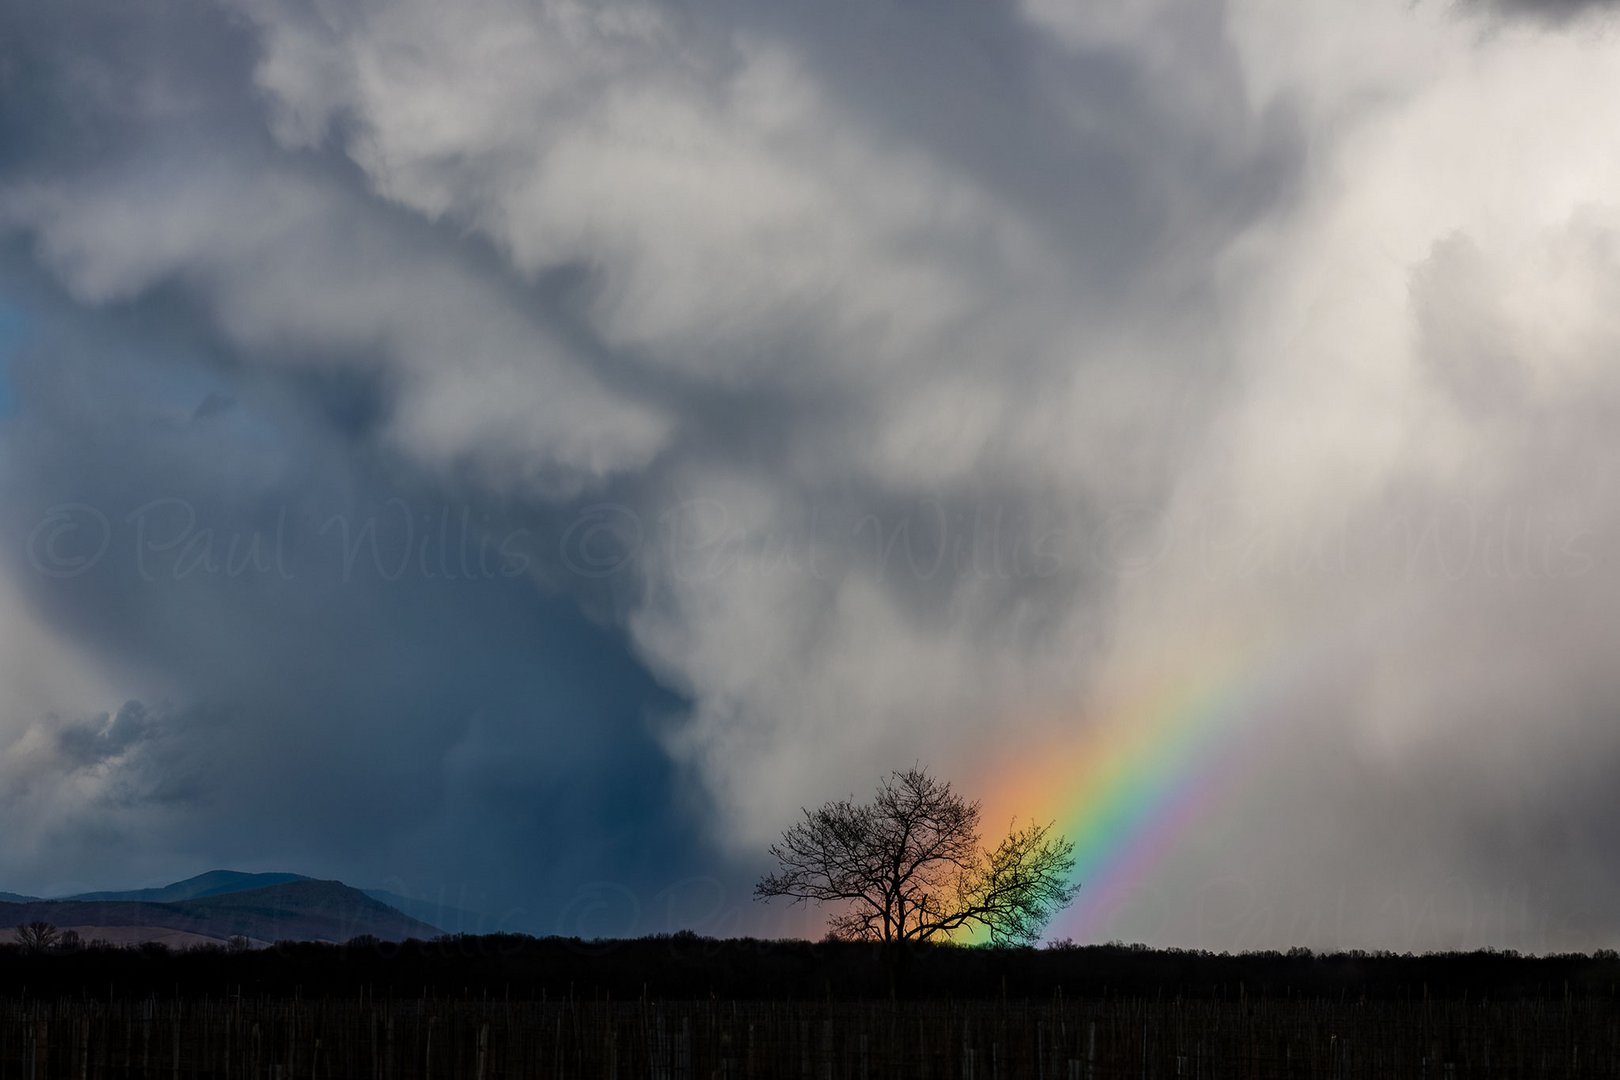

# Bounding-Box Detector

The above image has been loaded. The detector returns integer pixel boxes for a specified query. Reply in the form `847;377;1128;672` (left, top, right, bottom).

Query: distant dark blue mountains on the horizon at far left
0;871;441;942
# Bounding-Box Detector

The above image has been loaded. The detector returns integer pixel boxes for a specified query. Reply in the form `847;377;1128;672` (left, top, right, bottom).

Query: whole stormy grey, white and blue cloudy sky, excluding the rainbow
0;0;1620;950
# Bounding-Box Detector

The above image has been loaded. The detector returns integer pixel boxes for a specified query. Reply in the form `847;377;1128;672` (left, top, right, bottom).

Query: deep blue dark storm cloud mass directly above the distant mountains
5;262;701;929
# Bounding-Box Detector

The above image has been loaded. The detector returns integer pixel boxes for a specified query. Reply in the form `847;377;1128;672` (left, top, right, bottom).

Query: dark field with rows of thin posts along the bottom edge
0;999;1620;1080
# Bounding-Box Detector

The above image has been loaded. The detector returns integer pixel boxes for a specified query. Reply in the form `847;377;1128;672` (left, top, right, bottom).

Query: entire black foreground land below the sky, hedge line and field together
0;936;1620;1080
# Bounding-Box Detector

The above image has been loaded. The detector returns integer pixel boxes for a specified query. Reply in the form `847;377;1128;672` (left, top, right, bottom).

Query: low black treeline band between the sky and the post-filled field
0;933;1620;1001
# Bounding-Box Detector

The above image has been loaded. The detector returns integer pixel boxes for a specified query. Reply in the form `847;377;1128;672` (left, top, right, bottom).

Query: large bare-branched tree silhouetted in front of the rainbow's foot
753;767;1079;944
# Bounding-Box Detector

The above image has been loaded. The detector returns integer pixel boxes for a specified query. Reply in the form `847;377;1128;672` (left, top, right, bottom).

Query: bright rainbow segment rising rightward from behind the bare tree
959;641;1286;942
